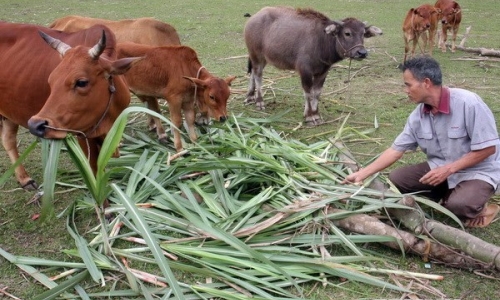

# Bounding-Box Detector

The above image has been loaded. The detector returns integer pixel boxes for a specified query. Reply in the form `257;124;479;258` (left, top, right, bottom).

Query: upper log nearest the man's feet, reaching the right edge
388;196;500;270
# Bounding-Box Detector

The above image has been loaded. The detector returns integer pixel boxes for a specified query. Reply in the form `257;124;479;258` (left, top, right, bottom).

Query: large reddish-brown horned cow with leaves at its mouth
0;22;138;189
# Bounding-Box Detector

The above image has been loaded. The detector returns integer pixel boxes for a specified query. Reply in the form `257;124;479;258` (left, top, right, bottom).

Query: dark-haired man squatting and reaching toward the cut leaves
344;57;500;227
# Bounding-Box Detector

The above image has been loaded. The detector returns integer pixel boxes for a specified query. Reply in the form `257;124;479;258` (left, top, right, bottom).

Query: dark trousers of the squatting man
389;162;495;219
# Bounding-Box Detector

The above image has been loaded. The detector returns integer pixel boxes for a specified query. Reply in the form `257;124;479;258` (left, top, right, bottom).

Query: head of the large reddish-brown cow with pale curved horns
28;32;137;139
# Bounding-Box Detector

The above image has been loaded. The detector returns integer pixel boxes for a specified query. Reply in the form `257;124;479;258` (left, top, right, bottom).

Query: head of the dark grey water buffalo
325;18;382;59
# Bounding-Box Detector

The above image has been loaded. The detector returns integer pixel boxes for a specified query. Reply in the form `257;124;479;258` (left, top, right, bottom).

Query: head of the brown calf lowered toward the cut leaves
184;76;236;122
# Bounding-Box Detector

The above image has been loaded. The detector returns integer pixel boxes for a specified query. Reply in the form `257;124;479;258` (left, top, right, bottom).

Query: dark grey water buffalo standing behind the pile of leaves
245;7;382;124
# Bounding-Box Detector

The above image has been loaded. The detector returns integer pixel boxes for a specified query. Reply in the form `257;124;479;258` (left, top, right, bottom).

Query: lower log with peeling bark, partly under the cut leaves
328;208;488;269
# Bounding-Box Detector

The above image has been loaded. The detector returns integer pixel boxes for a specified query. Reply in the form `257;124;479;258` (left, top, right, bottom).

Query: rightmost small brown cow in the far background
434;0;462;52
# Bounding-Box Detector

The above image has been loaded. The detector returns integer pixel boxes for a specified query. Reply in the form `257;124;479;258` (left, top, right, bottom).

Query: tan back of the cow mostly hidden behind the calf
49;15;181;46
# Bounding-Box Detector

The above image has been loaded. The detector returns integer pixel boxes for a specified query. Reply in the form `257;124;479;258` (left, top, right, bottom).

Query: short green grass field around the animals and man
0;0;500;299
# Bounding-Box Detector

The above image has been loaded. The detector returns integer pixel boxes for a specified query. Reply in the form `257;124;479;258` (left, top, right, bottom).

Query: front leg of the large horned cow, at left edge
0;117;38;190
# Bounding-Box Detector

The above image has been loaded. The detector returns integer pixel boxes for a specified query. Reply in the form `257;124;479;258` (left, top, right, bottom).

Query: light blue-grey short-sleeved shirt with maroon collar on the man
392;87;500;189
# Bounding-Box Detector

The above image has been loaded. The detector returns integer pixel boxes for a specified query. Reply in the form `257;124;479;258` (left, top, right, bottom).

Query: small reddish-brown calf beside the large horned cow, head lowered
117;43;234;151
